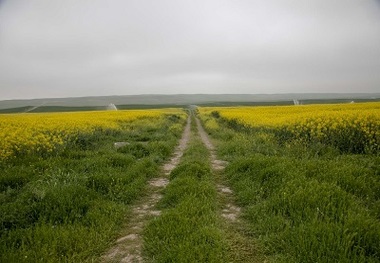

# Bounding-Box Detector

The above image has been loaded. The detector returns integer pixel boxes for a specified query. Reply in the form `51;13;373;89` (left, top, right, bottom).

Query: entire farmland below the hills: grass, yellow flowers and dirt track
0;103;380;262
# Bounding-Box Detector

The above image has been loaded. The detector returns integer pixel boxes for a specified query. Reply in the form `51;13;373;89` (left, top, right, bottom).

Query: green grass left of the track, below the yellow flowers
0;115;185;262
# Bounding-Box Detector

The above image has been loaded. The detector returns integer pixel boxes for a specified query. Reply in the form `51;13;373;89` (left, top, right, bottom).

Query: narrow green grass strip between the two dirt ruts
144;114;226;262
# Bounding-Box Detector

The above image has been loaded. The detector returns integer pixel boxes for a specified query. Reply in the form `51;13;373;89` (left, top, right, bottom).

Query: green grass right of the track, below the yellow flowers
202;111;380;262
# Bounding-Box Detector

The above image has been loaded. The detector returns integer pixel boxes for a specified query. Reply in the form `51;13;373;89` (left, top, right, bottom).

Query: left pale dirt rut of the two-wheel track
100;117;191;263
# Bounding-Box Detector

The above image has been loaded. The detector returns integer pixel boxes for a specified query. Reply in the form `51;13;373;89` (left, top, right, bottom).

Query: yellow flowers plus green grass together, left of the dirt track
0;109;186;262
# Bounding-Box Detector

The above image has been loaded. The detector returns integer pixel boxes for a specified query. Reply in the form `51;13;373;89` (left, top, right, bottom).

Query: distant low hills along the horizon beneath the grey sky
0;93;380;113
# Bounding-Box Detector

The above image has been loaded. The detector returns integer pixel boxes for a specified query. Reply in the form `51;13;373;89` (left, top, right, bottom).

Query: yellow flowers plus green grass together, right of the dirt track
199;103;380;262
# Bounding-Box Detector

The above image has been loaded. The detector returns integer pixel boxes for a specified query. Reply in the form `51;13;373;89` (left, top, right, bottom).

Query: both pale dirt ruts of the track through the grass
101;114;240;263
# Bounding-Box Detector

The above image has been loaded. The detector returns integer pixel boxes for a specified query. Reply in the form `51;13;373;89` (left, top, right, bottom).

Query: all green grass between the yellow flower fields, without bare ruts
0;105;380;263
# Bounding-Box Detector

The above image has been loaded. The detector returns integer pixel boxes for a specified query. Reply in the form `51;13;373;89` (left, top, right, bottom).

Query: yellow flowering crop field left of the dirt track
0;109;178;160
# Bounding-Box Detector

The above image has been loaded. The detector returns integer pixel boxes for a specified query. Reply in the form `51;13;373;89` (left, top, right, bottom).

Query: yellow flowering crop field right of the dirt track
200;102;380;153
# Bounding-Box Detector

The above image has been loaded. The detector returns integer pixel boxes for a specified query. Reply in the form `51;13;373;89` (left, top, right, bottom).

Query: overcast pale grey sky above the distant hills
0;0;380;100
